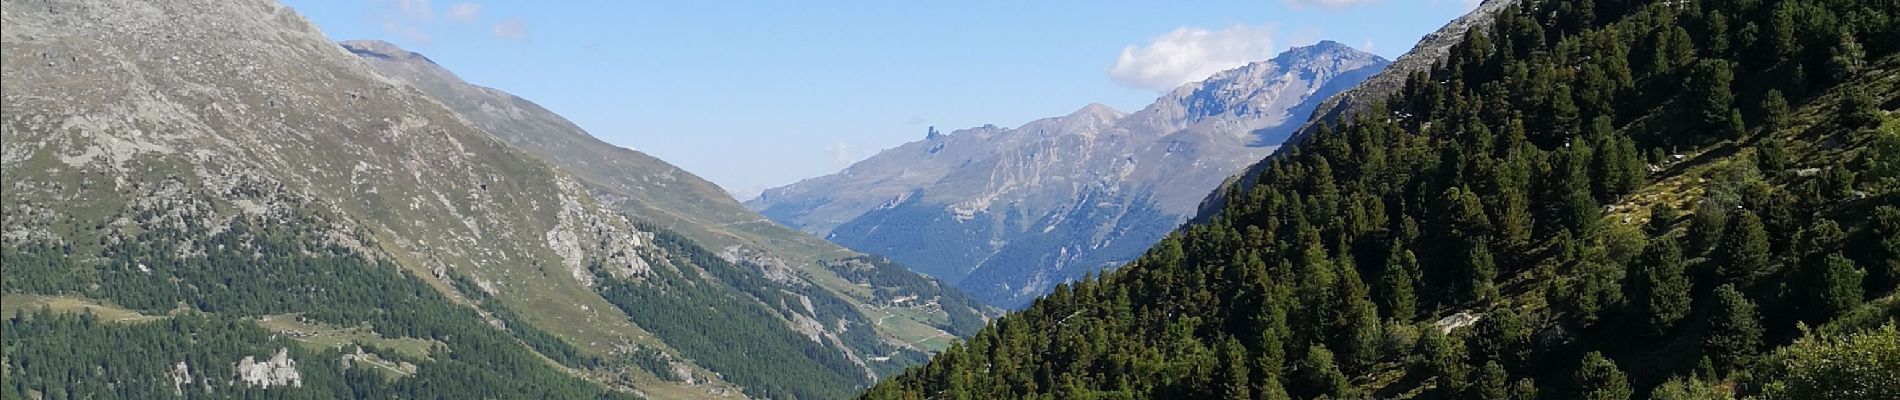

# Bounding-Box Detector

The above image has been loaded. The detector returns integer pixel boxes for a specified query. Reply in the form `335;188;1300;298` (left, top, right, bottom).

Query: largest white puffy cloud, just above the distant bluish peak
1108;25;1273;91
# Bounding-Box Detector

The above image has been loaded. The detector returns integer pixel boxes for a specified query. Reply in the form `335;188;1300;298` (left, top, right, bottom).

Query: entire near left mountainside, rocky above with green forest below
0;2;977;398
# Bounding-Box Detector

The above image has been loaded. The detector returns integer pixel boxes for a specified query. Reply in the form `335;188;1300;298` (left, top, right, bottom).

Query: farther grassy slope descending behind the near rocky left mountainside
342;40;994;362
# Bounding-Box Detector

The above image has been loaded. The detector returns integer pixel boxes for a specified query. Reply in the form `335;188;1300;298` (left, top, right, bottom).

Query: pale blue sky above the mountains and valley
287;0;1474;197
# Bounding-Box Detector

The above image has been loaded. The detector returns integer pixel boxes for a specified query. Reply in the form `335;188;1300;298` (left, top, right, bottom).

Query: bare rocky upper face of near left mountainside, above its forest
0;2;733;396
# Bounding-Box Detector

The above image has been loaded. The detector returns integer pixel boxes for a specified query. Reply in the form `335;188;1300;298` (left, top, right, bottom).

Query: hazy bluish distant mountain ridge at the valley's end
747;42;1387;307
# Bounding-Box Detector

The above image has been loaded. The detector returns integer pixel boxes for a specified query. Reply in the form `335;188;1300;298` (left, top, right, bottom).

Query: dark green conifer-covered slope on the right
866;0;1900;400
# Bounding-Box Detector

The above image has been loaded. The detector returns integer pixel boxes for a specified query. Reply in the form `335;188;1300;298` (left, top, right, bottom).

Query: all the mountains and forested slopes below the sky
0;0;1900;400
